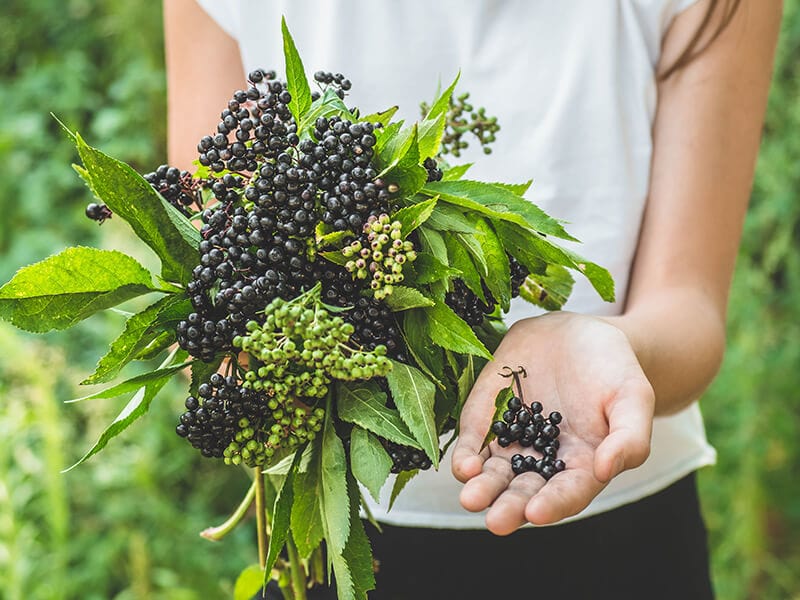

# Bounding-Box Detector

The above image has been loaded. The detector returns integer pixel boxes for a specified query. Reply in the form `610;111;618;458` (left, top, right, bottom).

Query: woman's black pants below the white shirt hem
267;474;713;600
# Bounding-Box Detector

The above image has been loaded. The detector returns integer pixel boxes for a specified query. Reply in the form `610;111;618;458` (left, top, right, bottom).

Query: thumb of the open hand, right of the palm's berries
594;380;655;483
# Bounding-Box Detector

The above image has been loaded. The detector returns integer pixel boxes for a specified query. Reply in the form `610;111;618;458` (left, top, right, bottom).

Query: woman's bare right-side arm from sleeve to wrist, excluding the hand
609;0;781;414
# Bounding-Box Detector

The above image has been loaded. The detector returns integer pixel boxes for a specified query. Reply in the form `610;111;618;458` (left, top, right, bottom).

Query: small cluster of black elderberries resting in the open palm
492;396;566;479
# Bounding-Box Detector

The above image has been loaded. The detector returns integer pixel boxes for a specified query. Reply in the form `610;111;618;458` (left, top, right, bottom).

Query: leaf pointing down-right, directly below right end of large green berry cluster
336;382;420;448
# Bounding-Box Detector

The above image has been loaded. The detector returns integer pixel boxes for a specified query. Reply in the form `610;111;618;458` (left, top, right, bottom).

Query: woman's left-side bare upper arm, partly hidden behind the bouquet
164;0;245;171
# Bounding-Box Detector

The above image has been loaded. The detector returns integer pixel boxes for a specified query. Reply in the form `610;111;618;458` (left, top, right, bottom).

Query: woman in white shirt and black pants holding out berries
165;0;781;599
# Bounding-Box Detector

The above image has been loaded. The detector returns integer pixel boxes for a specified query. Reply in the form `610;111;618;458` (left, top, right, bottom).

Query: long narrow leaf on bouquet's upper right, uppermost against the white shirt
423;179;577;241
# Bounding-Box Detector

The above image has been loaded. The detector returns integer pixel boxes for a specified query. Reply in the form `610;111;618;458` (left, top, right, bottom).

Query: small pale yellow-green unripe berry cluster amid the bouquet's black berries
342;214;417;300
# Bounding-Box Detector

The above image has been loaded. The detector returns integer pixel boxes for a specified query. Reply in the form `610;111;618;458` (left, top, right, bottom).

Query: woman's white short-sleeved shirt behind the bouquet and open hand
198;0;715;529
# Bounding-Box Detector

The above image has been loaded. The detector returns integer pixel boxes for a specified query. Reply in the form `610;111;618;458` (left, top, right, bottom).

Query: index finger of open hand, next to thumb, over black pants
524;469;604;525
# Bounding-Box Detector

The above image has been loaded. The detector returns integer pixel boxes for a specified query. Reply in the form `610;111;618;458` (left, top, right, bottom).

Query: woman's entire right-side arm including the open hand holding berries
453;0;781;534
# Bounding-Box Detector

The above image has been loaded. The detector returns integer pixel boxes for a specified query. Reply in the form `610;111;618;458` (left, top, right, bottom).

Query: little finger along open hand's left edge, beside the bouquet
452;363;502;482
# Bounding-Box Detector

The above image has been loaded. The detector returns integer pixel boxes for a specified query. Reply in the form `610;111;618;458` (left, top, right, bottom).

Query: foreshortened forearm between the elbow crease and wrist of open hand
605;287;725;415
